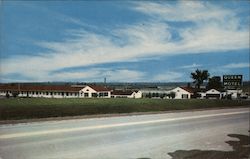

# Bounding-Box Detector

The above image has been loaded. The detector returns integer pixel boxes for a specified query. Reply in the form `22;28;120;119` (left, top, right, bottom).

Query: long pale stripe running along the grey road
0;111;249;139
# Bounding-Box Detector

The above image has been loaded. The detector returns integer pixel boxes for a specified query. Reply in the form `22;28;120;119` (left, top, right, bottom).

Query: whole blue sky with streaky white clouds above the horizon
0;0;250;82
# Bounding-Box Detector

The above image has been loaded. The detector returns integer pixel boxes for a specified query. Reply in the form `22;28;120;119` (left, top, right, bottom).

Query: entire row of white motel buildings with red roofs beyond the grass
0;84;246;99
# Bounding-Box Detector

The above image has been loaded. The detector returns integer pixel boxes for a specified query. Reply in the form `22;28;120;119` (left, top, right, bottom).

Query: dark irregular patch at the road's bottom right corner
138;134;250;159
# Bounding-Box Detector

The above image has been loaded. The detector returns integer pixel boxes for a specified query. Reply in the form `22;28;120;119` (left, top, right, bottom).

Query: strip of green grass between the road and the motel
0;98;250;120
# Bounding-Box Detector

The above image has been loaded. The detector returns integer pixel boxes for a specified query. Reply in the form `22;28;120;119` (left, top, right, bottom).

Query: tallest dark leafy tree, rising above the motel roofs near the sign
191;69;209;89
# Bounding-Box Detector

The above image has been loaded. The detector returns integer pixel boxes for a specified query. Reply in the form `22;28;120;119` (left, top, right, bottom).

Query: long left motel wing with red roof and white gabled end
0;85;111;98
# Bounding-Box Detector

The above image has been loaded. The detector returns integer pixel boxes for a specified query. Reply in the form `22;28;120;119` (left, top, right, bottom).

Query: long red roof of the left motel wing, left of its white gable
0;84;84;92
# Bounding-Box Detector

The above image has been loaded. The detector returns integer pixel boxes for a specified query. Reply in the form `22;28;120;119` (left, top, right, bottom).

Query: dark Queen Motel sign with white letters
223;75;242;88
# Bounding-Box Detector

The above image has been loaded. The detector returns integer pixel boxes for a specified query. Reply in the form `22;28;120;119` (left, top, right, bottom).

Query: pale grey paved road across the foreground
0;108;249;159
